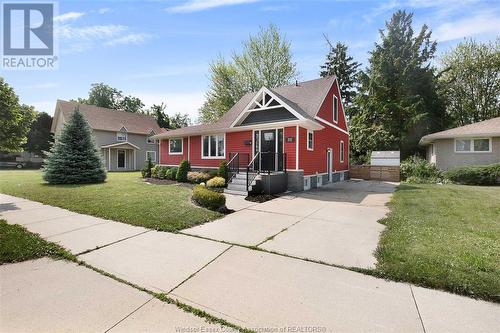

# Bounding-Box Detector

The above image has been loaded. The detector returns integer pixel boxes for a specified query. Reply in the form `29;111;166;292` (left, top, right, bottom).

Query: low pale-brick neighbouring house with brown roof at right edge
420;117;500;170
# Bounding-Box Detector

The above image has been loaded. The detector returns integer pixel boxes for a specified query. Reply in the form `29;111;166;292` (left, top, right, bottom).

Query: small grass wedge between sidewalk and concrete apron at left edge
0;220;75;265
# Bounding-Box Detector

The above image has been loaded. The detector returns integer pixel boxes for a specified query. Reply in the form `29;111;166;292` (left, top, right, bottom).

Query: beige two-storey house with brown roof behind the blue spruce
51;100;166;171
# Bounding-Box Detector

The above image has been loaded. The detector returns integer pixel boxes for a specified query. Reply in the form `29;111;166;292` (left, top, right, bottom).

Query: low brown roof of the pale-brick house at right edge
420;117;500;145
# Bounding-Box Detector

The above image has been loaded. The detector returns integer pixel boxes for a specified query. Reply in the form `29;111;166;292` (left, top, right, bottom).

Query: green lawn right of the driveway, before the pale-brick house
376;184;500;301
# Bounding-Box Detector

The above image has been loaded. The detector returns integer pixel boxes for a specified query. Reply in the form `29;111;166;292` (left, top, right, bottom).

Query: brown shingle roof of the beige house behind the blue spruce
56;100;166;135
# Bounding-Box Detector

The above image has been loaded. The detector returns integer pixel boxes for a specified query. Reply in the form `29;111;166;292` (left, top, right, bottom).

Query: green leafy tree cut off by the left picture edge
0;77;36;152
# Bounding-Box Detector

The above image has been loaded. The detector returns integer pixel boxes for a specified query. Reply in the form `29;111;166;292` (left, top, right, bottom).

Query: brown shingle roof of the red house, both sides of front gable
156;76;335;137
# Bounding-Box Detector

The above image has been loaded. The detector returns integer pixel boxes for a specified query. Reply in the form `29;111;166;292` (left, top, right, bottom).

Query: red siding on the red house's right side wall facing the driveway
299;82;349;175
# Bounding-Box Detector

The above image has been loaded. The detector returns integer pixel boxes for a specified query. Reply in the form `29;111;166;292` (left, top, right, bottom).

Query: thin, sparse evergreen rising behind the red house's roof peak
319;36;361;106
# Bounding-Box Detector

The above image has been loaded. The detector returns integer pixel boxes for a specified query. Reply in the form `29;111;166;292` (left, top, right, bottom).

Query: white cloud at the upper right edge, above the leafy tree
433;12;500;42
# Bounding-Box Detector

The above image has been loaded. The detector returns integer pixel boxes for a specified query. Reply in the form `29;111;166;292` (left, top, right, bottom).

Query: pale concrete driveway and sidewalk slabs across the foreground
0;187;500;333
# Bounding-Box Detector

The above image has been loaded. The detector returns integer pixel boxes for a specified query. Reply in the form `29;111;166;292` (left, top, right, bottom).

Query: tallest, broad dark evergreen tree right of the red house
350;10;446;160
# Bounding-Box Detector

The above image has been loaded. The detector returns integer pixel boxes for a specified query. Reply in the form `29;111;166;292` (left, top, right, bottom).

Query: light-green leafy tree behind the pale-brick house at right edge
439;37;500;127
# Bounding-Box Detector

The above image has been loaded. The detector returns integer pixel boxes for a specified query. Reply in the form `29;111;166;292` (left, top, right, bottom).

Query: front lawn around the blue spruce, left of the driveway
0;170;222;231
